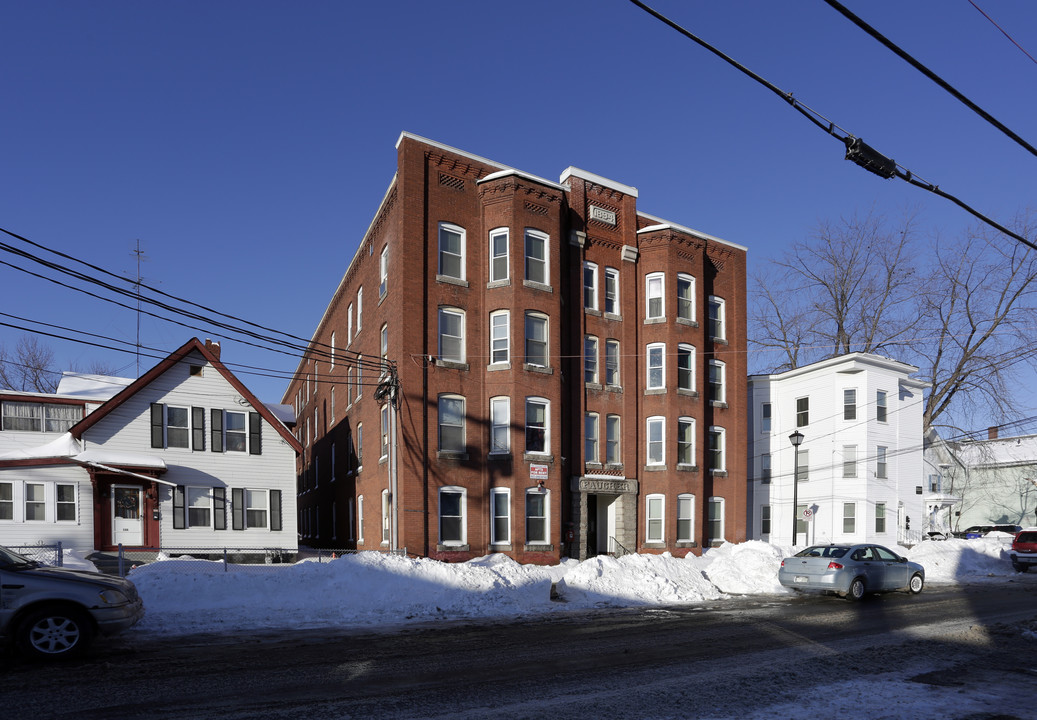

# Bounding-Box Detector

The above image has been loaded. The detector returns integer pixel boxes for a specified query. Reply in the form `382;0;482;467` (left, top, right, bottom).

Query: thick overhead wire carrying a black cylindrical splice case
630;0;1037;250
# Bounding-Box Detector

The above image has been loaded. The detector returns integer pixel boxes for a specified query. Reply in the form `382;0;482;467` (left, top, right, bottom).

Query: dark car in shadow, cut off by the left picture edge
0;547;144;660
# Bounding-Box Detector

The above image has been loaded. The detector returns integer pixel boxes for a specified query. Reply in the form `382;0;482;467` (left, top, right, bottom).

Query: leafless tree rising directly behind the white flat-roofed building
750;210;918;371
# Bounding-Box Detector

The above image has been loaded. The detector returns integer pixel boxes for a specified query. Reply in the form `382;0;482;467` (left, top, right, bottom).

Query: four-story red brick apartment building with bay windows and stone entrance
283;133;747;563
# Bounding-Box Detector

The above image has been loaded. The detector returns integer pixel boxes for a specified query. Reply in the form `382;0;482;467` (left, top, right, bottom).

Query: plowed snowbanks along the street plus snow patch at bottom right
68;535;1037;720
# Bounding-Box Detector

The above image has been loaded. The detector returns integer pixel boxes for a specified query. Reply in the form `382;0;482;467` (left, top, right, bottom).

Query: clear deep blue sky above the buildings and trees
0;0;1037;417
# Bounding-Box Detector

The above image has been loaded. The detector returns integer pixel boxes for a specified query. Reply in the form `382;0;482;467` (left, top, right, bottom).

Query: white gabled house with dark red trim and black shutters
0;339;301;551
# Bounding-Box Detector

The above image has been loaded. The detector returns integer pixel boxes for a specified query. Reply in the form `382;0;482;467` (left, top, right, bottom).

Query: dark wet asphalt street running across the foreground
0;585;1037;720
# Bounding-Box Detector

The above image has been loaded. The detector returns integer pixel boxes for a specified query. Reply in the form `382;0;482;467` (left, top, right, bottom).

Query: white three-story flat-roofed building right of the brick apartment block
748;353;926;545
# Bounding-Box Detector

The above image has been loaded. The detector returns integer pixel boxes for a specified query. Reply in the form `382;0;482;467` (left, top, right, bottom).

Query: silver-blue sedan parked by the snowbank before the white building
778;545;925;600
